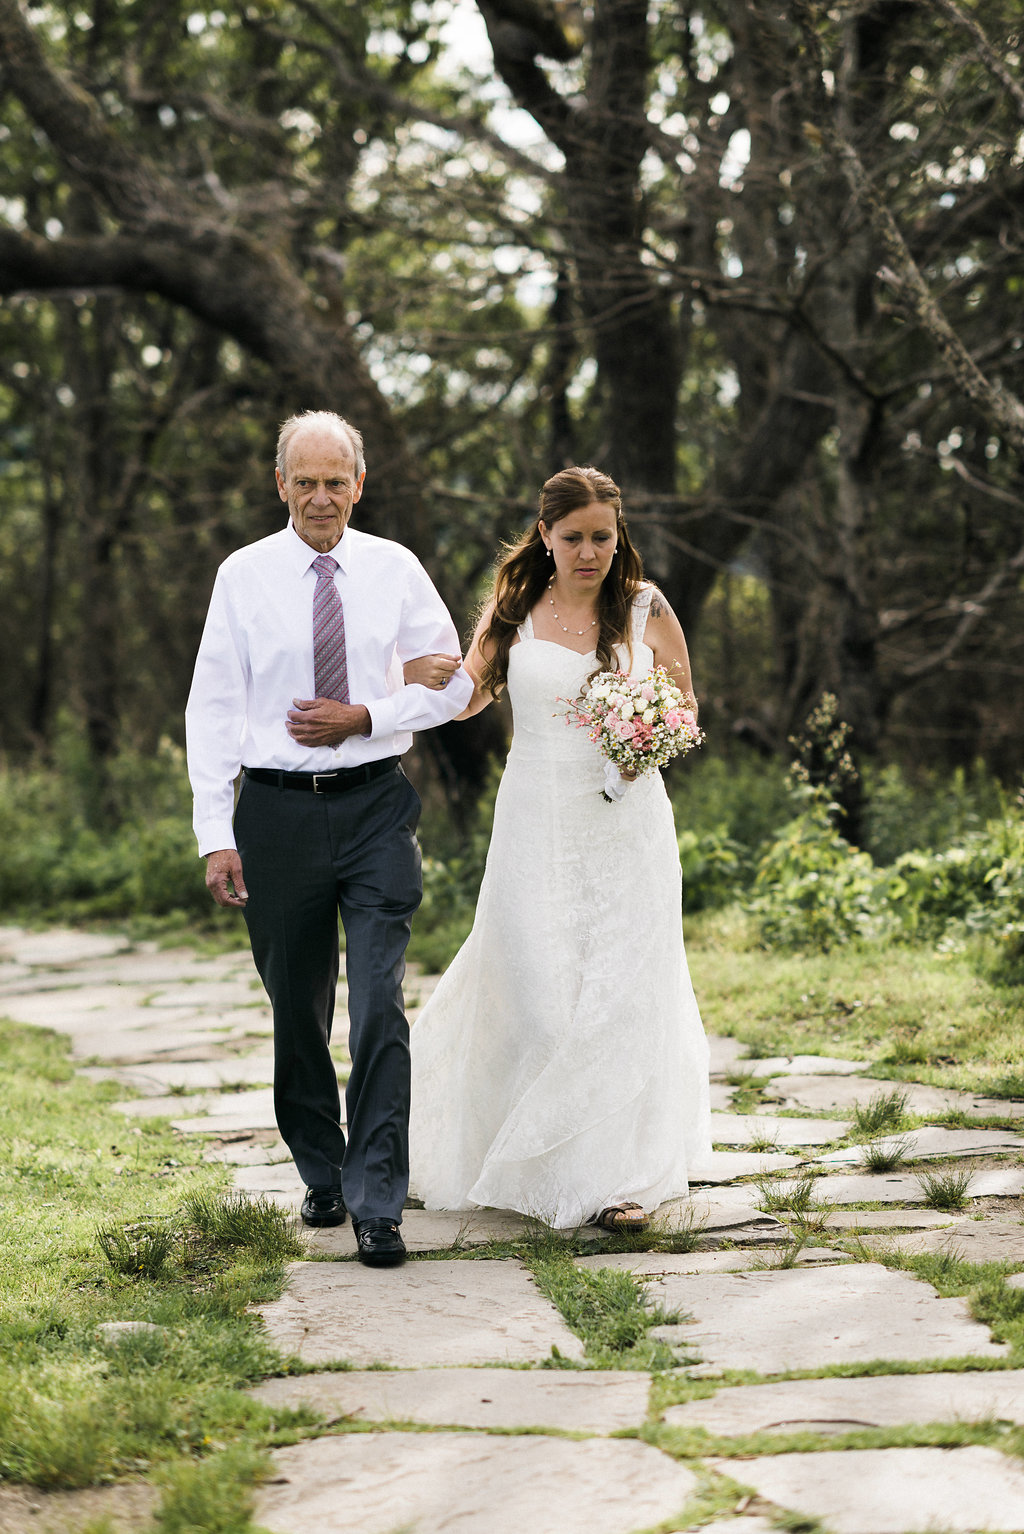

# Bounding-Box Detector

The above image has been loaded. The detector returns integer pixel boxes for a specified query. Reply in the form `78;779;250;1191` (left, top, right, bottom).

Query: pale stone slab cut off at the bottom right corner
708;1445;1024;1534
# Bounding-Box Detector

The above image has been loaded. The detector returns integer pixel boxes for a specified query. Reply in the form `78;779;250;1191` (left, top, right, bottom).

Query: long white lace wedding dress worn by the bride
409;588;711;1227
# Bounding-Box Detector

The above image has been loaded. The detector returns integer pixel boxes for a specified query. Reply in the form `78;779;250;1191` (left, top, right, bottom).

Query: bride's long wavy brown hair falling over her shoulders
480;466;644;695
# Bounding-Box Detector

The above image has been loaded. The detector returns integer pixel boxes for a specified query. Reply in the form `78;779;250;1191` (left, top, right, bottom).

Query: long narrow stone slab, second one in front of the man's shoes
250;1368;650;1433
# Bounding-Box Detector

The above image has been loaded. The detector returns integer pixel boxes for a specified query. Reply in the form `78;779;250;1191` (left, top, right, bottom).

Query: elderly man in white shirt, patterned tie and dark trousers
185;411;472;1266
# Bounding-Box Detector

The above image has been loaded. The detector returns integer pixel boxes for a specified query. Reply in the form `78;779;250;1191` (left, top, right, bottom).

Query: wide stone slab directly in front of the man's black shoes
256;1257;583;1368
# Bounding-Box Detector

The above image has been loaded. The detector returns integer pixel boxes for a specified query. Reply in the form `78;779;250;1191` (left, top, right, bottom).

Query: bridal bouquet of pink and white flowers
566;666;704;799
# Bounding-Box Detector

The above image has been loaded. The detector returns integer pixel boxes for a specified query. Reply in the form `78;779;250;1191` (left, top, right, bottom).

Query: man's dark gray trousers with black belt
235;767;423;1221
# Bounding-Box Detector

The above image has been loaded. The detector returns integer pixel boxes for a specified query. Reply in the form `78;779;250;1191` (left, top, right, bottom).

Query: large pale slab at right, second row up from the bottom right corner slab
619;1253;1007;1374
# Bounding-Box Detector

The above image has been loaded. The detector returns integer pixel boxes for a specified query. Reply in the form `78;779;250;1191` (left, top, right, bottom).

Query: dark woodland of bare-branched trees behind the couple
0;0;1024;944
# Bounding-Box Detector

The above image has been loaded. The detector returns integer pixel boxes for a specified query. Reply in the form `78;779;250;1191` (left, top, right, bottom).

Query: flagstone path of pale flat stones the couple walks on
0;928;1024;1534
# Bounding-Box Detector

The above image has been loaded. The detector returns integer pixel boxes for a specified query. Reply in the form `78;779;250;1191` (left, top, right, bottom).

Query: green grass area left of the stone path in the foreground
0;1023;303;1515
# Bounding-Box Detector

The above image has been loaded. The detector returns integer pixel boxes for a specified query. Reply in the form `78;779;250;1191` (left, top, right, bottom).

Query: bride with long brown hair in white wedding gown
406;468;711;1230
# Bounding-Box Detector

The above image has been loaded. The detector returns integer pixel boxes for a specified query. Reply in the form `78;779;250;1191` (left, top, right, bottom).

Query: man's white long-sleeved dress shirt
185;523;472;854
